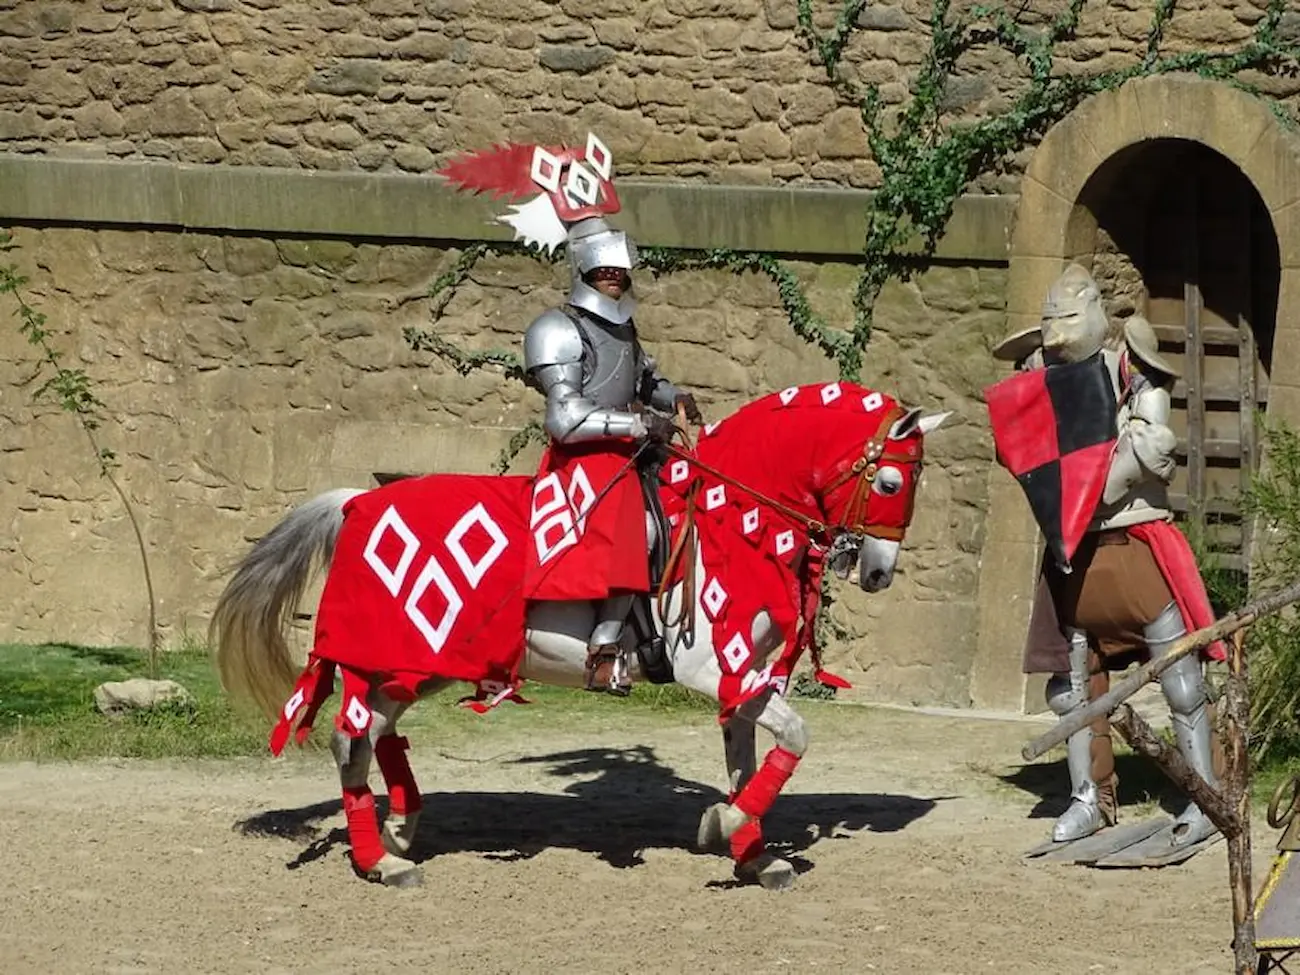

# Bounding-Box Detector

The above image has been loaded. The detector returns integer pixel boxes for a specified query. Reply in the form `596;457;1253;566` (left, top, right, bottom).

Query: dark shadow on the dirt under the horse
234;745;954;872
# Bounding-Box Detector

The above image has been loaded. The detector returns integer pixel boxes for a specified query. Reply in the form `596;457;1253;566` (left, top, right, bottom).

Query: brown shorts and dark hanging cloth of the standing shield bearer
1023;528;1174;673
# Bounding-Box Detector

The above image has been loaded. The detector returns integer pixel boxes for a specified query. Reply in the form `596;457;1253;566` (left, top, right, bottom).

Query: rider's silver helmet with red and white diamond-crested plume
437;133;637;325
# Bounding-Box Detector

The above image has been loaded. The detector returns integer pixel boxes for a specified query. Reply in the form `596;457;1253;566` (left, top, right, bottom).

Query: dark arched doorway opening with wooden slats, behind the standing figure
1074;139;1281;569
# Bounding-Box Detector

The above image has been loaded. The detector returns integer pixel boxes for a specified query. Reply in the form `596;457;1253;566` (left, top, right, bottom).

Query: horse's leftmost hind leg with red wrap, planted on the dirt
330;690;421;887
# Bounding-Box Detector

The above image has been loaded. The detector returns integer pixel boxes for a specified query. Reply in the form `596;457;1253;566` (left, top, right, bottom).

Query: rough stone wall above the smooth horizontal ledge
0;0;1300;191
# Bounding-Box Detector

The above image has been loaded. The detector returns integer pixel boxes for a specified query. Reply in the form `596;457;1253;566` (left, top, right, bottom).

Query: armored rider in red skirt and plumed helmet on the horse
439;134;703;696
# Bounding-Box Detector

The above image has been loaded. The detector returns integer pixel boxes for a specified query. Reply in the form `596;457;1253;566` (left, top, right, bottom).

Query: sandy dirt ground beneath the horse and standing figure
0;702;1277;975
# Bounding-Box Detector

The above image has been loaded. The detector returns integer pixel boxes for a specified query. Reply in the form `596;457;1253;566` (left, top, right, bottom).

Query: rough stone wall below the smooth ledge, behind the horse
0;228;1005;703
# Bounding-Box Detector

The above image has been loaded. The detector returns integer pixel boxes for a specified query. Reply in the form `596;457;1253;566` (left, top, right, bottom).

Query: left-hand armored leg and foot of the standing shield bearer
1047;628;1115;842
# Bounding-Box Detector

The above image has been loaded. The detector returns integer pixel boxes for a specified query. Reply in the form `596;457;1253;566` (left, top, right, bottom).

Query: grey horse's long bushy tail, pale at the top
208;488;365;720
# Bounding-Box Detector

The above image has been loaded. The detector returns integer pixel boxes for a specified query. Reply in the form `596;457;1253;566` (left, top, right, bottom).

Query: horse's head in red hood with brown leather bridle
820;393;949;593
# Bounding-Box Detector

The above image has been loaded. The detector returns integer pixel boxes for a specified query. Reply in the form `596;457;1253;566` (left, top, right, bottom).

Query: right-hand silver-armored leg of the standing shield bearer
1143;602;1219;846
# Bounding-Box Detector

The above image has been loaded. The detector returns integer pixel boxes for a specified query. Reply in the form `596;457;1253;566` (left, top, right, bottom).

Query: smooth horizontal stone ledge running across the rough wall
0;153;1015;264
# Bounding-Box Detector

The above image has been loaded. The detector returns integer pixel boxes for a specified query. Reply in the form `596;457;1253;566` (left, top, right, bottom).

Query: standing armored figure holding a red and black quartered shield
987;264;1223;858
